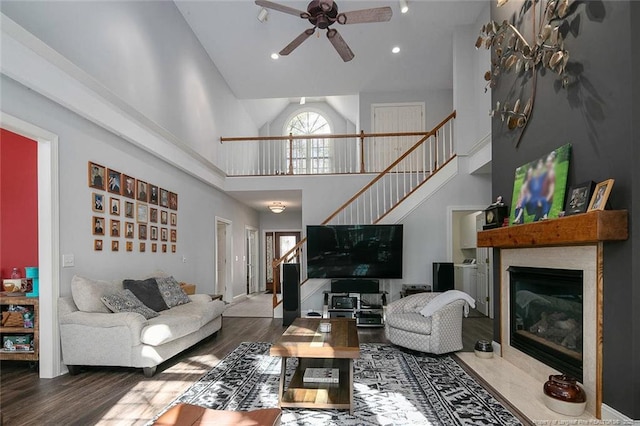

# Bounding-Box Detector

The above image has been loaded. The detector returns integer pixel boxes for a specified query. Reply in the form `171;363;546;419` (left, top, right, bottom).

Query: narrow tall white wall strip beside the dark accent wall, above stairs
453;3;491;155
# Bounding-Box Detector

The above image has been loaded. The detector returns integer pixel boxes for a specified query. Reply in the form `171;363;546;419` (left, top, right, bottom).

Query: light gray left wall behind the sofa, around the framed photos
0;76;259;295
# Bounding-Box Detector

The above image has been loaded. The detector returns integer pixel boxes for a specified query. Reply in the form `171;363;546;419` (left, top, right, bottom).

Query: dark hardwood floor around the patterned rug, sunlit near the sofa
0;312;492;426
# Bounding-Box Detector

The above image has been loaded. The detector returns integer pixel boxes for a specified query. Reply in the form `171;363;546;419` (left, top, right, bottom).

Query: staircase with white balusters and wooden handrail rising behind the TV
272;111;456;310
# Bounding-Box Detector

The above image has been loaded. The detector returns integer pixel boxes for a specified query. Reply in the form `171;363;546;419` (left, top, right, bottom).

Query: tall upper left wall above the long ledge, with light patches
2;1;257;166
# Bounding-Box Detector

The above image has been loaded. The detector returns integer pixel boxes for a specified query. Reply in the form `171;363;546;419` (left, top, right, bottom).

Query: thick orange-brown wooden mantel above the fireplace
478;210;629;249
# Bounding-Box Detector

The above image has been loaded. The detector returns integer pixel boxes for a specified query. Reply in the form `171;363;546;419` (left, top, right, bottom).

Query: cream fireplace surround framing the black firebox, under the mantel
500;245;602;415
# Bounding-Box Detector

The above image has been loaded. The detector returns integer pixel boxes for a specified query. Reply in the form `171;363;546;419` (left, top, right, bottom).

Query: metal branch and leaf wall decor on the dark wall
476;0;571;146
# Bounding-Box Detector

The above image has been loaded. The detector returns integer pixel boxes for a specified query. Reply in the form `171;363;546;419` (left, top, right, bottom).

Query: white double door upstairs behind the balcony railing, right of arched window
368;103;425;171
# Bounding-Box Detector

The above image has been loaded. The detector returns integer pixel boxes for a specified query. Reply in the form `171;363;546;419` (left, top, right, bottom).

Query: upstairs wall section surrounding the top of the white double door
359;90;453;133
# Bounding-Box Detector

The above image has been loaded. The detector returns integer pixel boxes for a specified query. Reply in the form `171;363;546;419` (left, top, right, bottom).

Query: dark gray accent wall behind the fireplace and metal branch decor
490;1;640;419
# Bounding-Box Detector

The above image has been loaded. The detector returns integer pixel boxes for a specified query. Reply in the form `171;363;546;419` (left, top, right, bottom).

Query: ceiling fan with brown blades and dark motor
256;0;393;62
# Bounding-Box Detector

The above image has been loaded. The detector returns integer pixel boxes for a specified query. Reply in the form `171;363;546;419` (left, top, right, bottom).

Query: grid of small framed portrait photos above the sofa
88;161;178;253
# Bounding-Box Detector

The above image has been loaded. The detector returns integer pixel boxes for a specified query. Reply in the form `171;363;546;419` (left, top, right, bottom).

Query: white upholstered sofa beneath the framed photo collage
58;277;225;377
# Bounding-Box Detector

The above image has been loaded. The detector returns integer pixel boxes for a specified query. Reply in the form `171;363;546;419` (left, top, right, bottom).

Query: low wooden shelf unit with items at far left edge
0;295;40;361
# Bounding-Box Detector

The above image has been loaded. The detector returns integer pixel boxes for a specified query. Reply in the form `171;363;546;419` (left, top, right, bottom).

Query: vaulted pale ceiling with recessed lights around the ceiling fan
175;0;486;109
